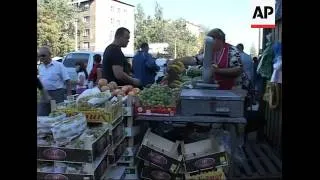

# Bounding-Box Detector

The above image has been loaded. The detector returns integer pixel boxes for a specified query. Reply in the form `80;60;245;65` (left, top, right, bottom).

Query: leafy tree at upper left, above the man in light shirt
37;0;83;56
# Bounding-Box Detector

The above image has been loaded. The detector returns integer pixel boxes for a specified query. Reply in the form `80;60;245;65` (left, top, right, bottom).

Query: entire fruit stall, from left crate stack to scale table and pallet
37;62;281;180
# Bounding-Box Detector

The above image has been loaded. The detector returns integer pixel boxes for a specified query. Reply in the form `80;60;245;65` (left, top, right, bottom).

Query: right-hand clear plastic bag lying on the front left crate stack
51;113;87;146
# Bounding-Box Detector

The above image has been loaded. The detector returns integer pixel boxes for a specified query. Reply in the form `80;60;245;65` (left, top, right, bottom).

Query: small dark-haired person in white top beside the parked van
76;61;88;94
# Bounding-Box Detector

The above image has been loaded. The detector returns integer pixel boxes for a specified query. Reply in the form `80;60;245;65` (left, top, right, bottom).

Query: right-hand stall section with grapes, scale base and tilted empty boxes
134;62;282;179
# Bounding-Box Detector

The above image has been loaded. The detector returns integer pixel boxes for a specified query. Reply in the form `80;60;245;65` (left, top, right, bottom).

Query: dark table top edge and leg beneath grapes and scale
135;114;247;177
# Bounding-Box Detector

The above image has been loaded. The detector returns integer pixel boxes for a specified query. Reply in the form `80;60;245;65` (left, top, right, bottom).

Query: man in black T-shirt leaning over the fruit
102;27;140;87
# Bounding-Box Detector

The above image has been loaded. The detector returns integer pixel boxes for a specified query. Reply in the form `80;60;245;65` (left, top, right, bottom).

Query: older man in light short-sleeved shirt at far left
38;47;71;103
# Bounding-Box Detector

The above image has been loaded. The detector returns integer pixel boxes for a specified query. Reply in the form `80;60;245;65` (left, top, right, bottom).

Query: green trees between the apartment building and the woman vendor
134;2;203;57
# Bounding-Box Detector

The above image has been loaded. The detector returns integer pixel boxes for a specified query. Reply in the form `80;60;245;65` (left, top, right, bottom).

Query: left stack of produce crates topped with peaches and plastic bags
37;81;144;180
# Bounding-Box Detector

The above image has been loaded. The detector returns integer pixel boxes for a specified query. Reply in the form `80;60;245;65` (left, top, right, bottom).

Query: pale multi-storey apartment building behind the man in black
72;0;134;54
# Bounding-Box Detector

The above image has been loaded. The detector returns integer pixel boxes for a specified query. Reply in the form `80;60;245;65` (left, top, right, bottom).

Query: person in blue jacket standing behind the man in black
132;43;160;87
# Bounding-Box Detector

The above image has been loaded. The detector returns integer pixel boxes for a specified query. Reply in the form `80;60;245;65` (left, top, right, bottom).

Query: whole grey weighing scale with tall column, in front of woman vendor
180;37;244;117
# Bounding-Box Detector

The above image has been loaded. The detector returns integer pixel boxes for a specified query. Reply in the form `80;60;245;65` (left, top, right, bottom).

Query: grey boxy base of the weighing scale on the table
180;89;244;117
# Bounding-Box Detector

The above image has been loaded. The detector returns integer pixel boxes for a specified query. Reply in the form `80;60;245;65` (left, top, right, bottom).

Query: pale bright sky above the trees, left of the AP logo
121;0;259;54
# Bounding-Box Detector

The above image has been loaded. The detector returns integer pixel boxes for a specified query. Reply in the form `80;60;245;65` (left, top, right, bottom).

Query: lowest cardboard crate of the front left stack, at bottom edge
37;148;108;180
